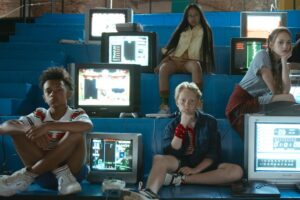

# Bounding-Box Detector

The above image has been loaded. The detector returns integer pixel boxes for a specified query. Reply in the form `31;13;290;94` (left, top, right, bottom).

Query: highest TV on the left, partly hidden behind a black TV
85;8;133;43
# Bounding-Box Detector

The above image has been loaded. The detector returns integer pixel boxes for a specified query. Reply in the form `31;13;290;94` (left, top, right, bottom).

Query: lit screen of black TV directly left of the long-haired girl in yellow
109;35;150;66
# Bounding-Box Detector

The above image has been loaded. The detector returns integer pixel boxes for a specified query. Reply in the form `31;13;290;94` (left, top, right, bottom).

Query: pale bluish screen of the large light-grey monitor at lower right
254;122;300;172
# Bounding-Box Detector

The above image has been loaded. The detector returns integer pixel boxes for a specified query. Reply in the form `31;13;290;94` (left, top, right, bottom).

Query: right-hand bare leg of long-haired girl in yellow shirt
184;61;203;90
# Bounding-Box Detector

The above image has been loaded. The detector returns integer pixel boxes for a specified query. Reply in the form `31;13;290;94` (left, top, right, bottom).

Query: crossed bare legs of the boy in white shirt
13;133;85;175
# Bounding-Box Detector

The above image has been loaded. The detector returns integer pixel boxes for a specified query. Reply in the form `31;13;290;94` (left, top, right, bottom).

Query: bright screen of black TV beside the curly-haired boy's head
77;68;130;106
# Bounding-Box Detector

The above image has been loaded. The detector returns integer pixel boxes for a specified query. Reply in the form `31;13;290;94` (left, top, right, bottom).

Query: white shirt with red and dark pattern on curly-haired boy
19;107;92;150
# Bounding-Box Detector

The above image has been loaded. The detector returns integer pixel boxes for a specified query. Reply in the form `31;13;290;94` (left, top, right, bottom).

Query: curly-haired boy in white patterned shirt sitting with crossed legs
0;67;93;196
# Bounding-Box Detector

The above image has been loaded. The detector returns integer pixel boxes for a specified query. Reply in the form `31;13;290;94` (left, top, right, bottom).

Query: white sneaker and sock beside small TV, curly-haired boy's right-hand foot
53;165;81;195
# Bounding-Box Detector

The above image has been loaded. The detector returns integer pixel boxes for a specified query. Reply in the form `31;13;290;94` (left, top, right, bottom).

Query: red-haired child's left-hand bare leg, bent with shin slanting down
146;155;179;194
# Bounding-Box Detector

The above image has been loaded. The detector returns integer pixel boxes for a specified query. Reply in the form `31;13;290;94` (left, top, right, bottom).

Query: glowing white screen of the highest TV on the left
91;13;126;37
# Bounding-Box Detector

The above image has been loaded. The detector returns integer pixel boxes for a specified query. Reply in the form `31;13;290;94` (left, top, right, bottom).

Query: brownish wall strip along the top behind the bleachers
0;0;284;17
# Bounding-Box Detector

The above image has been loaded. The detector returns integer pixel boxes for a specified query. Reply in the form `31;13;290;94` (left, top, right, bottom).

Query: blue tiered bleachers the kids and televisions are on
0;11;300;199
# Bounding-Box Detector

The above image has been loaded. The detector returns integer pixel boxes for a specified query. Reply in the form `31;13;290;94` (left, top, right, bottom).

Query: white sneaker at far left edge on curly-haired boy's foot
0;168;37;197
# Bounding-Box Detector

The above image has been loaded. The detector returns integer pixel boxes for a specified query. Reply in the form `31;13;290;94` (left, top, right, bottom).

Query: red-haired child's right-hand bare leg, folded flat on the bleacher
184;163;243;185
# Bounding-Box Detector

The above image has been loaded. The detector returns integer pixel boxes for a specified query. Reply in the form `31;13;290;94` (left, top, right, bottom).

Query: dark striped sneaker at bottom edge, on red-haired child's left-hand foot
121;189;159;200
